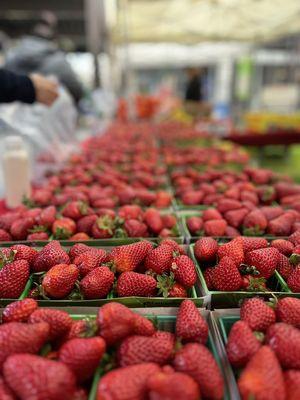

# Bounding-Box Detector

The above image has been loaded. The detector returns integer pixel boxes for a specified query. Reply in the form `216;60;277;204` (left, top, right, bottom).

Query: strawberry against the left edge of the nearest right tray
226;321;261;367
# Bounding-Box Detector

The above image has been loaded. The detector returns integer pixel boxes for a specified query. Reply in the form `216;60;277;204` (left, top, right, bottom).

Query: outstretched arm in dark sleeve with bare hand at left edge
0;69;58;106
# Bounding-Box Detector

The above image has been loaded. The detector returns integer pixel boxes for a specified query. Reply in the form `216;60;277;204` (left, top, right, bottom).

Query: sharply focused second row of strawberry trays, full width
0;235;300;309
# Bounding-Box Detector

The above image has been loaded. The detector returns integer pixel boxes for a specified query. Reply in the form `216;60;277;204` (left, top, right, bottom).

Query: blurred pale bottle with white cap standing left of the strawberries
3;136;30;208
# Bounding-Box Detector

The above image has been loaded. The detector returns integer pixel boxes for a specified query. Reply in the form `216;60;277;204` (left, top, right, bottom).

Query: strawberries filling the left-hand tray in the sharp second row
0;239;197;299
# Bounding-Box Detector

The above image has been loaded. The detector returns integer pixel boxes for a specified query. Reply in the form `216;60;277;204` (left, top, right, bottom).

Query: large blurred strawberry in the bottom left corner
3;354;76;400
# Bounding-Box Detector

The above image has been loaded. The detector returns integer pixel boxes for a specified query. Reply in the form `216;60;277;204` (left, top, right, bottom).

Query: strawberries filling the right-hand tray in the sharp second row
194;231;300;293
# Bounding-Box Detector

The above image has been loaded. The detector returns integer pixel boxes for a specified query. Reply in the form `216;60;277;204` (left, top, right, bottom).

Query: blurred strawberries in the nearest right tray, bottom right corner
226;297;300;400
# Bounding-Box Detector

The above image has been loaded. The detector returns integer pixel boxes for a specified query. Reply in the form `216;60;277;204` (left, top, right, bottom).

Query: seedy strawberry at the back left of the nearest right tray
240;297;276;332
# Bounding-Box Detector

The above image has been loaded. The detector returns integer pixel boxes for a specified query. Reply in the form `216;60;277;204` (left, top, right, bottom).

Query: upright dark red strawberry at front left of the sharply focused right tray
213;257;242;291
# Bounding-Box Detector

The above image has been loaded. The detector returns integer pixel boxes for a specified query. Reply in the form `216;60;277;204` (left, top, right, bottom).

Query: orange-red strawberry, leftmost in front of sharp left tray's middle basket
42;264;79;299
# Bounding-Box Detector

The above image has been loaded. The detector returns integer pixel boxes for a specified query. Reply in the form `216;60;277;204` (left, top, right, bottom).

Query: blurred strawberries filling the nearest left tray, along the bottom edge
0;299;224;400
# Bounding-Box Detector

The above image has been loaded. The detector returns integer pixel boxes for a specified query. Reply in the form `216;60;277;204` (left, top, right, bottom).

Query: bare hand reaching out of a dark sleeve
30;74;58;106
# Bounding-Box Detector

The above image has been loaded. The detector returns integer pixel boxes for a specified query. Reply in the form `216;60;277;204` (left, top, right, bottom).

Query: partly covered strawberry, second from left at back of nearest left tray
28;308;73;341
